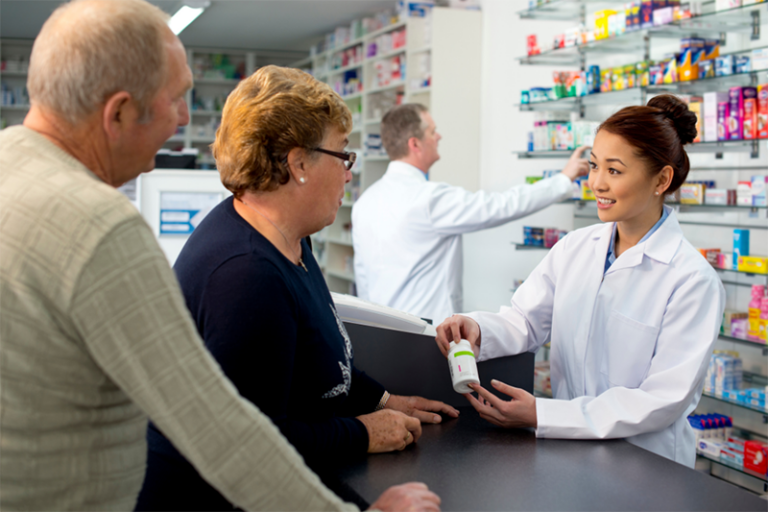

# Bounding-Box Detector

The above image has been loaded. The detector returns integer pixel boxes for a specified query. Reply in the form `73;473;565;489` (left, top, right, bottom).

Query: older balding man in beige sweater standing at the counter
0;0;439;512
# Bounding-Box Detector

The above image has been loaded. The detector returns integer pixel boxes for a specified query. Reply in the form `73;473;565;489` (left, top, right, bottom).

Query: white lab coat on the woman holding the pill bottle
468;209;725;467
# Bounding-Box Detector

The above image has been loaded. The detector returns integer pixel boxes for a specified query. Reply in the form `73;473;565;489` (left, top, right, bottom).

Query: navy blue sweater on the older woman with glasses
137;197;384;510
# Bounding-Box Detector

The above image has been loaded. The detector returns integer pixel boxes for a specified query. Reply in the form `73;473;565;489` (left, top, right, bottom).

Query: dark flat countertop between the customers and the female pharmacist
340;407;768;512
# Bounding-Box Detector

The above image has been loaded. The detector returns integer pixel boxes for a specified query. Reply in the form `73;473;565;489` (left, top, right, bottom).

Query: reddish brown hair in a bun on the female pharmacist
598;94;696;194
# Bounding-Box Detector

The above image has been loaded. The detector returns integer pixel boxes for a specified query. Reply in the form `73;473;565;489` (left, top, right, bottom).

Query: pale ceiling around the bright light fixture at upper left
0;0;396;51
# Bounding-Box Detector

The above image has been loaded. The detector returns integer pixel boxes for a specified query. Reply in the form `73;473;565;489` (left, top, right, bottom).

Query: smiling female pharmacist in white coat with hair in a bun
437;95;725;467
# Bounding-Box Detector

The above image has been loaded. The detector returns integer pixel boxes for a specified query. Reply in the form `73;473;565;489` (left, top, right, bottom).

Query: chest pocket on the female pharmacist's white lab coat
601;310;659;388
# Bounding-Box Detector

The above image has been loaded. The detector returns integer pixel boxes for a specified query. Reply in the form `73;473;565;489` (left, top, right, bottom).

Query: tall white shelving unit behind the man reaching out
292;8;482;293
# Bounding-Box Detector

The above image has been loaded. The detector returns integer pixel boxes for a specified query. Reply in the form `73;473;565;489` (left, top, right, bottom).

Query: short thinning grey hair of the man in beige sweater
27;0;168;124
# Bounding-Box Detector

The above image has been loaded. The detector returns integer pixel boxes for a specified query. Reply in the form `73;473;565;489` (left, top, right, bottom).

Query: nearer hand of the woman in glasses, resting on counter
357;408;421;453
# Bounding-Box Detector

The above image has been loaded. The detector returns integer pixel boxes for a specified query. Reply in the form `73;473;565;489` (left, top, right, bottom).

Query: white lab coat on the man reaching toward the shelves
352;161;572;325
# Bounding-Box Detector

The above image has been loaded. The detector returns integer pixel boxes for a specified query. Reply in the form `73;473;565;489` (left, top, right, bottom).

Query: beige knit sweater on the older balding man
0;126;357;512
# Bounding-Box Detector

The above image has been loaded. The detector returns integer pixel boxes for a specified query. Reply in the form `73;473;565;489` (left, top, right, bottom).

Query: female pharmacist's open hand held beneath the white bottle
464;379;538;428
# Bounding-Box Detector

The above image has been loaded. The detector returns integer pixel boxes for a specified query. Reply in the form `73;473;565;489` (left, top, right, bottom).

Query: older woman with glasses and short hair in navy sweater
137;66;458;510
